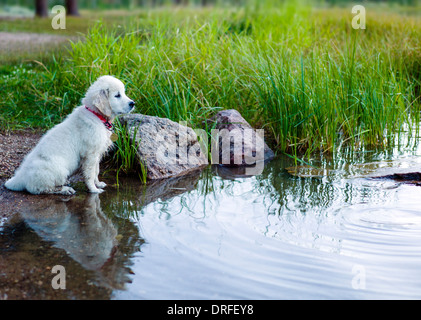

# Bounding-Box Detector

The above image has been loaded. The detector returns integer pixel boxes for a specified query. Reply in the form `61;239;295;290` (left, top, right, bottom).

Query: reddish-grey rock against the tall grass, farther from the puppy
211;109;275;166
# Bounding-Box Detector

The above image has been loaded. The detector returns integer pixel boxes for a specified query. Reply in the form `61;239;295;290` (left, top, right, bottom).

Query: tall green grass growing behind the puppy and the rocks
0;1;421;160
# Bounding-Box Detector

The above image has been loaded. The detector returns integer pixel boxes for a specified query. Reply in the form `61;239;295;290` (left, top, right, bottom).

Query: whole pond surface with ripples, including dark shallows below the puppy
0;148;421;299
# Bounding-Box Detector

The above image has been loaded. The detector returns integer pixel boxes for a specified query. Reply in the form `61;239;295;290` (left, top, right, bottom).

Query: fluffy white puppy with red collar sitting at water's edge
5;76;134;195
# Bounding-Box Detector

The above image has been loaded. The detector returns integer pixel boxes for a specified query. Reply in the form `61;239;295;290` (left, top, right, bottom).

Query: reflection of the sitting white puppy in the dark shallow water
6;194;139;289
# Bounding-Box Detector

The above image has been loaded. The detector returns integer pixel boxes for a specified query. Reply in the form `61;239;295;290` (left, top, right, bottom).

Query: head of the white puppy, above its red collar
82;76;135;120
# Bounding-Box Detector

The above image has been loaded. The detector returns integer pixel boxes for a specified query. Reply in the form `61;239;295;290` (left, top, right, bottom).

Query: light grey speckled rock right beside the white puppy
120;114;208;180
